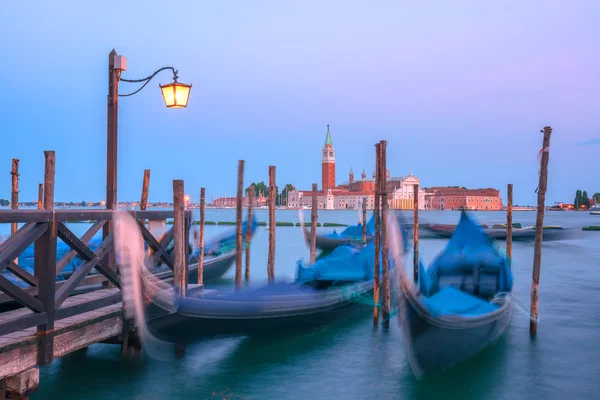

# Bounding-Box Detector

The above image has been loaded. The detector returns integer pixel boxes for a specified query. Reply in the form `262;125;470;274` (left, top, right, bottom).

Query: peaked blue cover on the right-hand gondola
419;211;513;306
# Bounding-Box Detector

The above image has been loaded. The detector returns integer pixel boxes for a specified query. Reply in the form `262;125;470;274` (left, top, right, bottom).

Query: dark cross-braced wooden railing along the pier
0;210;191;365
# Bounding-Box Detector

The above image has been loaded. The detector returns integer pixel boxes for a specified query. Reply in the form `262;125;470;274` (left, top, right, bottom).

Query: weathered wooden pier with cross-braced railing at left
0;210;193;400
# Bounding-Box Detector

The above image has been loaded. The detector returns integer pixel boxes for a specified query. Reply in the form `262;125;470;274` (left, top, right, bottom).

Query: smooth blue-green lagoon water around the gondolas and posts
0;209;600;400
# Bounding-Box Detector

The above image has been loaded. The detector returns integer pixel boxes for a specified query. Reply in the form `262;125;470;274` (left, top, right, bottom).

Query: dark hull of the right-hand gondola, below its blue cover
399;289;512;378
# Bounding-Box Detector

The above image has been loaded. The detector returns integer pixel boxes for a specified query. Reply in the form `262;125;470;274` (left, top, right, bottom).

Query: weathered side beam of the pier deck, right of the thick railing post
54;315;123;357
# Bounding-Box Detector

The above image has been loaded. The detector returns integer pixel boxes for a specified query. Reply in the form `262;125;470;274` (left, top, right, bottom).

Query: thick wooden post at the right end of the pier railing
173;180;187;297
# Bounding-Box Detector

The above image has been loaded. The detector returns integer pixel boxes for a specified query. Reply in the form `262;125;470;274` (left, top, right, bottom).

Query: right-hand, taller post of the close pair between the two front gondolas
379;140;391;327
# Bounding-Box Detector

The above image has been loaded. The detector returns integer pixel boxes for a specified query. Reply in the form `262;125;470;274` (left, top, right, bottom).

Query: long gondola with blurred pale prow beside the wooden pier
117;209;393;343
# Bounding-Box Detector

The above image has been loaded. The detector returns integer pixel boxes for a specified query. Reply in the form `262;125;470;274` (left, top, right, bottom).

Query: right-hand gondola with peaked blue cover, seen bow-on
396;211;512;378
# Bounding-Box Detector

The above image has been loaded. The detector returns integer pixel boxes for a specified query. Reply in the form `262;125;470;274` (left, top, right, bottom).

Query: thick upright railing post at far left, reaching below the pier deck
33;151;56;365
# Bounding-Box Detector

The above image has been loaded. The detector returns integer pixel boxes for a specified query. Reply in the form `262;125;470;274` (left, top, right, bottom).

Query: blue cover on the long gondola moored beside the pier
296;244;382;282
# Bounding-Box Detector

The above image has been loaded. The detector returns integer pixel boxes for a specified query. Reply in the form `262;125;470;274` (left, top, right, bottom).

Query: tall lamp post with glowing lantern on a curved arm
102;49;192;276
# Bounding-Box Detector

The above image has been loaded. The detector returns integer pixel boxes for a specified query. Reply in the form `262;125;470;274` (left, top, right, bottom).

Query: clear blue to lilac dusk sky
0;0;600;205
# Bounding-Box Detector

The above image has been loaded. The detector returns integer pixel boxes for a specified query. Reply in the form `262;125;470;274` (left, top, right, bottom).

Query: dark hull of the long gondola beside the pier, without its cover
148;282;373;343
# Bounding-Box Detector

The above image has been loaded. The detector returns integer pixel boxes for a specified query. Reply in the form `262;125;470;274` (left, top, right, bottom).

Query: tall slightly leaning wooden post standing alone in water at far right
529;126;552;336
